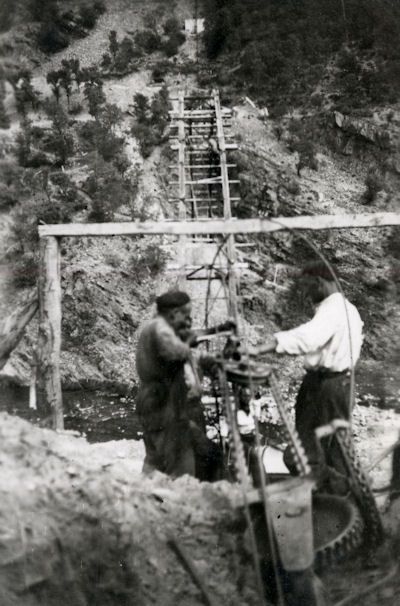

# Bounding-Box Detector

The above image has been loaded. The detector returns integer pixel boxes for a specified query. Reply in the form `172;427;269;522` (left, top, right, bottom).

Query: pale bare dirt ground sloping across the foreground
0;412;400;606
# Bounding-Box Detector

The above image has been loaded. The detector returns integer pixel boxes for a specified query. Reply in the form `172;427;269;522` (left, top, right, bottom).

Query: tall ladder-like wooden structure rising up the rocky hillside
170;90;241;320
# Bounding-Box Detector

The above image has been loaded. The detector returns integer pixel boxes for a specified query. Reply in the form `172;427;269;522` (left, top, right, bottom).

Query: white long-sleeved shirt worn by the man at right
274;292;363;372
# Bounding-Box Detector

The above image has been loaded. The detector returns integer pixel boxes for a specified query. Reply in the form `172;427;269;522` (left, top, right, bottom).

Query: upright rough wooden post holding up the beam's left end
38;236;64;429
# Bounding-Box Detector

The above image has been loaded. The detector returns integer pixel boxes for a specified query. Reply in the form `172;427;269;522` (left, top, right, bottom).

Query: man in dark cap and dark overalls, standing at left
136;290;232;481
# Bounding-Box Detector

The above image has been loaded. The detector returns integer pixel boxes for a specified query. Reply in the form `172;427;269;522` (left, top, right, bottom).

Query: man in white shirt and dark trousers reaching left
250;261;363;491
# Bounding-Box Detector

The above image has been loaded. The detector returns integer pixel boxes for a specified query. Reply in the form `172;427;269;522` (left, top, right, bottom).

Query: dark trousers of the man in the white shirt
284;371;351;492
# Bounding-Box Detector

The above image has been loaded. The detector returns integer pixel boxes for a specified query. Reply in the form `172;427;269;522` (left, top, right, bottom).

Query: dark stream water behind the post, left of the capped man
0;386;141;442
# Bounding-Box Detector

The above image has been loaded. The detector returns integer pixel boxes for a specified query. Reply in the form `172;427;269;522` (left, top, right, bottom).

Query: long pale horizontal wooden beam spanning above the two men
38;213;400;238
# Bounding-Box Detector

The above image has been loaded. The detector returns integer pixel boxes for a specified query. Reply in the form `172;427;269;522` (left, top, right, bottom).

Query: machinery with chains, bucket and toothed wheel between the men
203;336;383;605
